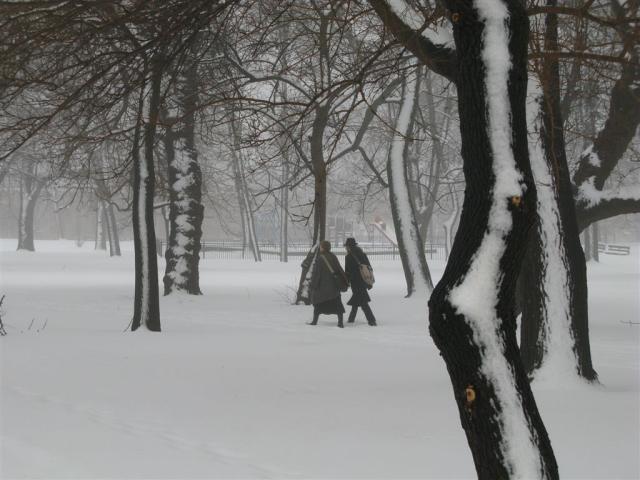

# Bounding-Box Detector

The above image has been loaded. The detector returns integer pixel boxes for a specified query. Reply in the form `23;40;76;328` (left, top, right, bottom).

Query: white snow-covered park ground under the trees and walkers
0;240;640;479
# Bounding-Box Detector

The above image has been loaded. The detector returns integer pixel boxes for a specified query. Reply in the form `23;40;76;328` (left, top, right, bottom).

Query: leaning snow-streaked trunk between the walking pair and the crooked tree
387;70;433;297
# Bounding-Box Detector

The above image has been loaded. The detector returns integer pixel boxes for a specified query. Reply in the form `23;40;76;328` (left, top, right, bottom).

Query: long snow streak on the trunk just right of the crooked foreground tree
527;77;578;381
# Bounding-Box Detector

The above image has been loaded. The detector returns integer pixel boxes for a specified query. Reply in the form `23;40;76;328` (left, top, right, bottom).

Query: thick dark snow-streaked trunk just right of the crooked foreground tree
520;4;597;380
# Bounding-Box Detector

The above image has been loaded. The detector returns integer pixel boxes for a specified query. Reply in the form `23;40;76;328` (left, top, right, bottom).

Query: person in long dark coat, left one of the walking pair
309;240;347;328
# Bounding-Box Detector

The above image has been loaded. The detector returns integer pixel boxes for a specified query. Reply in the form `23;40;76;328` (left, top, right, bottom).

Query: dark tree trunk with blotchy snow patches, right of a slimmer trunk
163;59;204;295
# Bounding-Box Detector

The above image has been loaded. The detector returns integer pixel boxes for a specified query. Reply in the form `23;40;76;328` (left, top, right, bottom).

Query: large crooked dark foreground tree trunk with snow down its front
429;0;558;472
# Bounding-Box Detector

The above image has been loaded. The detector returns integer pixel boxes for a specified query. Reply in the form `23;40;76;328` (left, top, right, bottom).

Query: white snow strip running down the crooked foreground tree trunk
449;0;543;479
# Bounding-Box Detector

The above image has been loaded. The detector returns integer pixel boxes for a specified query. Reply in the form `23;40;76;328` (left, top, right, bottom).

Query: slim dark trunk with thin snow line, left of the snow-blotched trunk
131;62;163;332
